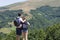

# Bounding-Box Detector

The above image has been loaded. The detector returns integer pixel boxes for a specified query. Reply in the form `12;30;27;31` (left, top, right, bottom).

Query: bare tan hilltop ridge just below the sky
0;0;60;11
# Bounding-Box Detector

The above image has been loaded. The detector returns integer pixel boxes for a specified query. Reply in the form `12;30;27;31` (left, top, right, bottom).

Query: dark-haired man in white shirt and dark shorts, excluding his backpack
16;13;26;40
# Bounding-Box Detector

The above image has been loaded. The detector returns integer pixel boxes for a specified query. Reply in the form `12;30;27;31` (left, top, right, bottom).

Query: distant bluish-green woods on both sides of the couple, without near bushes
0;5;60;28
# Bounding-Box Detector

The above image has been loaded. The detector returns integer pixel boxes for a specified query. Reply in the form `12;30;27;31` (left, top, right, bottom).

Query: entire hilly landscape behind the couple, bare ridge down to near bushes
0;0;60;40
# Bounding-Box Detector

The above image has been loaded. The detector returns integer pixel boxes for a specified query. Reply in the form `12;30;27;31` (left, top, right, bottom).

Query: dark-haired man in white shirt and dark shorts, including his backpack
14;13;26;40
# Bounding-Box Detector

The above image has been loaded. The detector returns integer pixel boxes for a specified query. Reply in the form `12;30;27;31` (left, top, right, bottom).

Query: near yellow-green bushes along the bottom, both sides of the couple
0;24;60;40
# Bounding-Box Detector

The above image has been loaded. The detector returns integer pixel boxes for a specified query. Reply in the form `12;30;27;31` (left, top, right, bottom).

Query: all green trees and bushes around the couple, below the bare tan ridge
0;2;60;40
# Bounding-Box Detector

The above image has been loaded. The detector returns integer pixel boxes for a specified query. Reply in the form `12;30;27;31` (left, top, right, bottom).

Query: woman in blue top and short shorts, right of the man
22;17;30;40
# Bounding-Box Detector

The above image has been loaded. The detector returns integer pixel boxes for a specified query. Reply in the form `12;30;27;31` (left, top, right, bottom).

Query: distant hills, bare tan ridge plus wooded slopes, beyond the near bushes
0;0;60;28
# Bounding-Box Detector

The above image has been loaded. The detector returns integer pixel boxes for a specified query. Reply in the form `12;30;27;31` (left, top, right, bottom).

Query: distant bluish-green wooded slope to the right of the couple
30;5;60;28
